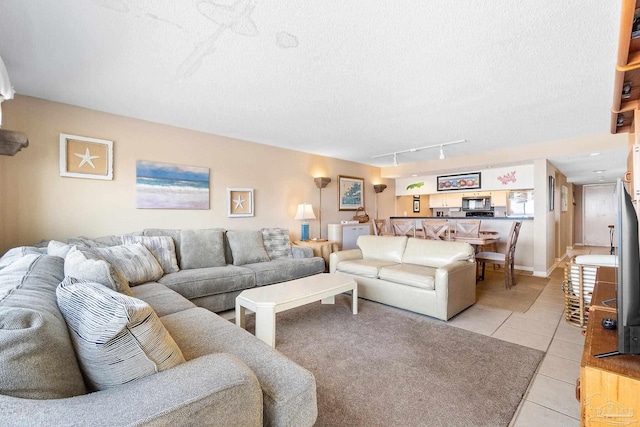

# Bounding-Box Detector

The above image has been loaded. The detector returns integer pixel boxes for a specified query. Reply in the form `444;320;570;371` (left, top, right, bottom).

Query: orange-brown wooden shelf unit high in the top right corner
611;0;640;133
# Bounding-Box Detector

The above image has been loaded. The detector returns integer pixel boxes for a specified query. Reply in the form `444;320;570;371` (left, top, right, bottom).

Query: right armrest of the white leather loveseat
435;261;476;319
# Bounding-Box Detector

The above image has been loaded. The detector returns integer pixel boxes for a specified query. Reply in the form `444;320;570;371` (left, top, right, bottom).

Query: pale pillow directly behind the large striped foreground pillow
64;246;132;295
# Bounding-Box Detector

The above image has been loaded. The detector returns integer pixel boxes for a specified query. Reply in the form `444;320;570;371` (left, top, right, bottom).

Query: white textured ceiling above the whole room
0;0;626;184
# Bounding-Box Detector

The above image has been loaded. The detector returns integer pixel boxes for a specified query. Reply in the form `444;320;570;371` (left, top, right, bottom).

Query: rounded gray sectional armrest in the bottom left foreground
0;353;262;426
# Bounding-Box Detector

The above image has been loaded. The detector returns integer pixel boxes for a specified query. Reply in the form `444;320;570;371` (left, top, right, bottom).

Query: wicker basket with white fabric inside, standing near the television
562;261;598;328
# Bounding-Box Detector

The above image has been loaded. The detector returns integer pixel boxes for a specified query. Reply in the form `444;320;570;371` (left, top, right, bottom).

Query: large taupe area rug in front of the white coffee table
238;295;543;427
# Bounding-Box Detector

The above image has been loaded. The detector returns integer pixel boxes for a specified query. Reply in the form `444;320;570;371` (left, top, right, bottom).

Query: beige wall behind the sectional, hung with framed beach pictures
0;96;395;253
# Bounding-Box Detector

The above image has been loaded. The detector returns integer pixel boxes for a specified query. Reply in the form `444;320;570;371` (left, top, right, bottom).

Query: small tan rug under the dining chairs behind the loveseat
476;265;550;313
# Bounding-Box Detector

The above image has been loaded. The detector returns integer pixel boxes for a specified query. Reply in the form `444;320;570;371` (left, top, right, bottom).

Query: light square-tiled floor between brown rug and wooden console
447;247;609;427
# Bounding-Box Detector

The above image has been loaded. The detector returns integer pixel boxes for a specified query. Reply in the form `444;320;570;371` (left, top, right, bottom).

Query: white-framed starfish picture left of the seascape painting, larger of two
60;133;113;180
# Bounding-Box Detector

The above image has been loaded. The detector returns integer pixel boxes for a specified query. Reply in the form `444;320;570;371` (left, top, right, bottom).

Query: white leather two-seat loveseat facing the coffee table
330;236;476;320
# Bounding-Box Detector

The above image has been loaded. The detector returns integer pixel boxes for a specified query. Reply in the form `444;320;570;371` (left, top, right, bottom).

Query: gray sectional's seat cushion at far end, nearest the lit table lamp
243;257;325;286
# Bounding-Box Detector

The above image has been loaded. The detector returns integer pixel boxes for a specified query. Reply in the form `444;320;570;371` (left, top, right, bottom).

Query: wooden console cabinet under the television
576;271;640;426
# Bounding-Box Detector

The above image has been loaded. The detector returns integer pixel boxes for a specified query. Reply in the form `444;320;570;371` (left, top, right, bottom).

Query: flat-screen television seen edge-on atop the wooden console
596;179;640;357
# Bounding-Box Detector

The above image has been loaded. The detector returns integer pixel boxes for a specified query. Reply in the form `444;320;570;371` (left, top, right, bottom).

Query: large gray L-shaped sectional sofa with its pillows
0;229;324;426
